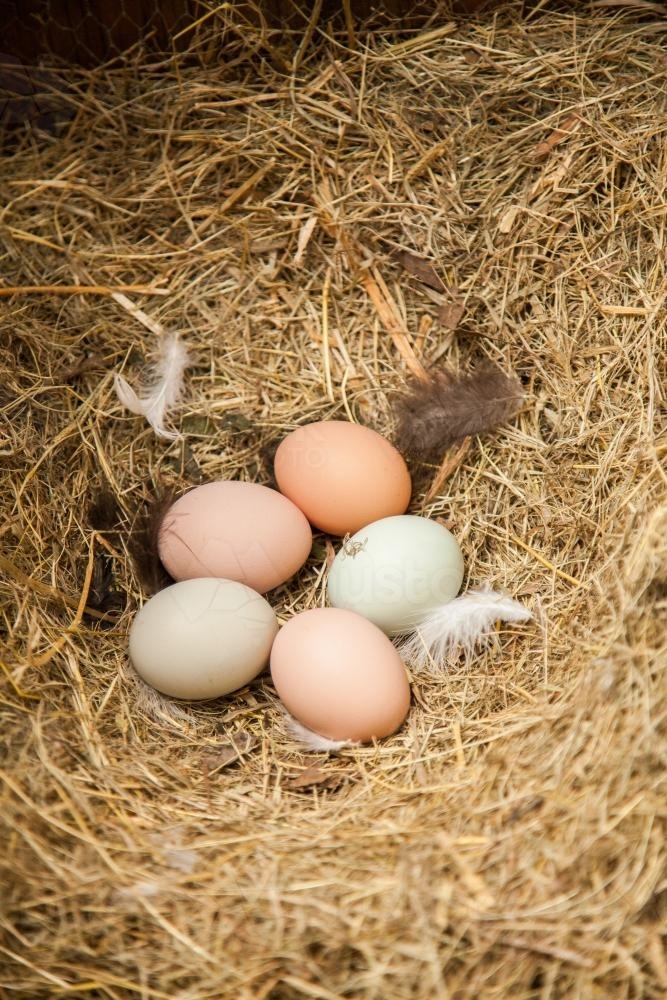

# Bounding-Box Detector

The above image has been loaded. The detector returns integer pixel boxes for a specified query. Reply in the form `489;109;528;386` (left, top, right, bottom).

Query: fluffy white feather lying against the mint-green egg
398;587;533;670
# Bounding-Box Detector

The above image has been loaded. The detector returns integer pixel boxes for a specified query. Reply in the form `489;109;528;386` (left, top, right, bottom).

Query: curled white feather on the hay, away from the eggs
114;335;188;441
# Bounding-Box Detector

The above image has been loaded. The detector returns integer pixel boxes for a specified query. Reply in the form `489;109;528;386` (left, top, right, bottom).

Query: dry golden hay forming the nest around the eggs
0;5;667;1000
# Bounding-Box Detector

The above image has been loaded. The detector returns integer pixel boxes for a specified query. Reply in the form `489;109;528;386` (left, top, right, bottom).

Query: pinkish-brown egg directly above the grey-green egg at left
157;480;313;594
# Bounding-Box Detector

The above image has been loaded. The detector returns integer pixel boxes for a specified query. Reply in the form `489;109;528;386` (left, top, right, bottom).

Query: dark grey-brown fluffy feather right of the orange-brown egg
394;364;523;458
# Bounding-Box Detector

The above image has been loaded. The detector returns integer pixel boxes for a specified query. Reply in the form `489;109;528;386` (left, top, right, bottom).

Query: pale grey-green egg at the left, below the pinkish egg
129;577;278;701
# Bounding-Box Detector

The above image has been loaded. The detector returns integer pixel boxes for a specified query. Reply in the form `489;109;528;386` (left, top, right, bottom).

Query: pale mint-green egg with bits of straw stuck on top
327;514;463;635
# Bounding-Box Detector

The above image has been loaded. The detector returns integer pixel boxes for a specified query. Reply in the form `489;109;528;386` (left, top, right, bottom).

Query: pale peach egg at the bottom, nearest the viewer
270;608;410;743
